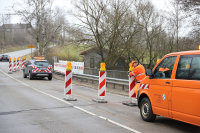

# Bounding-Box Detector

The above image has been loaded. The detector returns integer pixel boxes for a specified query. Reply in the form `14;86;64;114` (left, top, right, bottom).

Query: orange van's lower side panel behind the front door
172;79;200;126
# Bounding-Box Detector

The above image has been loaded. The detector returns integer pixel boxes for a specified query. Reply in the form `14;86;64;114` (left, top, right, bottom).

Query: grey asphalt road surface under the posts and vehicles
0;49;200;133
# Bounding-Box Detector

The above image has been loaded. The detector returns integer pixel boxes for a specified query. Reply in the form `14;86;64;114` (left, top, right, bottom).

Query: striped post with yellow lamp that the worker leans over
122;63;137;106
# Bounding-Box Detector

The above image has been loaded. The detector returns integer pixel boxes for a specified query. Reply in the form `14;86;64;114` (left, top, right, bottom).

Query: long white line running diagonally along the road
0;69;141;133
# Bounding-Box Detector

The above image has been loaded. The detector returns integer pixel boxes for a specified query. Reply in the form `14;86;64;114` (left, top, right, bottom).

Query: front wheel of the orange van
140;97;156;122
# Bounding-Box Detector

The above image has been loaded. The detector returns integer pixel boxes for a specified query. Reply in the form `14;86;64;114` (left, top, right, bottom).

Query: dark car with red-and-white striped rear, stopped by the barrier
23;59;52;80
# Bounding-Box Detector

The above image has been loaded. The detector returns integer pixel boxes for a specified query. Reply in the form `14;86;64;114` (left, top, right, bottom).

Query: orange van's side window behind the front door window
176;55;200;80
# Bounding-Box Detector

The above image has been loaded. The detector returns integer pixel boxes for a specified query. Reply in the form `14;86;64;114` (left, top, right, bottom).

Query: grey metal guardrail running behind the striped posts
54;71;129;90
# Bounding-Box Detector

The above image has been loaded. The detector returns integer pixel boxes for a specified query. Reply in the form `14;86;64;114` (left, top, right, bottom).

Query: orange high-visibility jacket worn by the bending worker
131;64;146;82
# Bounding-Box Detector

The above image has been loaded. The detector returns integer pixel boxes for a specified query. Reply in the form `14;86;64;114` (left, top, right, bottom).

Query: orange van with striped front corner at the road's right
137;50;200;126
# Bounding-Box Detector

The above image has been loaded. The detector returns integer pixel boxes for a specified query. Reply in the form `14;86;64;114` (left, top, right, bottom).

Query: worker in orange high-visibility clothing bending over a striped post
129;61;146;96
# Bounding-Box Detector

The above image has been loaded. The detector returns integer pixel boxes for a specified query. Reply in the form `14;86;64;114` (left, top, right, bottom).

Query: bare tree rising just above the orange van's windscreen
137;1;164;67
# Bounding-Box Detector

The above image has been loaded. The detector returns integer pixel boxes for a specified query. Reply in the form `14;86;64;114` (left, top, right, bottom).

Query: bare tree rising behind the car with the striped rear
14;0;60;55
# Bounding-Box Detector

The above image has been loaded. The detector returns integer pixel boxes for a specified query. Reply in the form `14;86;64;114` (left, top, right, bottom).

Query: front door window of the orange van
154;56;176;79
